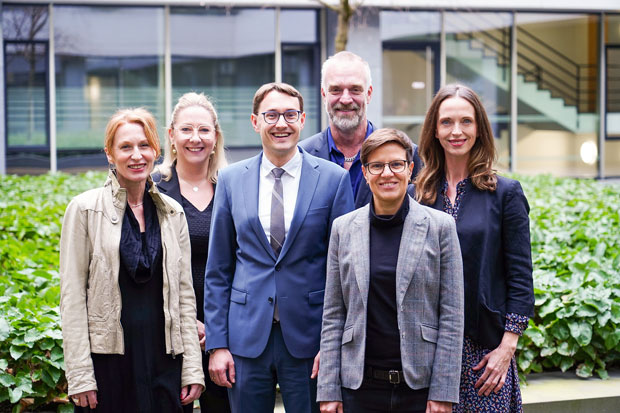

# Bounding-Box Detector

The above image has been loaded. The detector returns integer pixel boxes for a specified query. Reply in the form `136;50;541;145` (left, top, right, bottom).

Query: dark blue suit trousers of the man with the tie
228;324;319;413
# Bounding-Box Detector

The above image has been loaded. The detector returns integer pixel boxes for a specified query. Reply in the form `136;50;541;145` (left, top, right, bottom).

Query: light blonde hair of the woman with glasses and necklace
158;92;227;183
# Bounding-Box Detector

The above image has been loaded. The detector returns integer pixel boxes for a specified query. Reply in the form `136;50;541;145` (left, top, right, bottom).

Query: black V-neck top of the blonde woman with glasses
181;197;213;322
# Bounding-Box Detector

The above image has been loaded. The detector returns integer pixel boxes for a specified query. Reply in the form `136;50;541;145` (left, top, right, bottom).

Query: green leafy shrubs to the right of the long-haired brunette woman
518;176;620;378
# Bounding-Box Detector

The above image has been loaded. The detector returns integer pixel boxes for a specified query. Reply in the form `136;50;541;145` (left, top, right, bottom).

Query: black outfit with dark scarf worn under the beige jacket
83;193;182;413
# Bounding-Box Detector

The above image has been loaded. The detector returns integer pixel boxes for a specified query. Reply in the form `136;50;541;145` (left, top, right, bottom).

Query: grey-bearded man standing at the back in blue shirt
299;51;422;208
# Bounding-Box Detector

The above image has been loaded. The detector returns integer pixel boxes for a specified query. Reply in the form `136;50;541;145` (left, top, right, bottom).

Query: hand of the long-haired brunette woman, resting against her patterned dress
473;331;519;396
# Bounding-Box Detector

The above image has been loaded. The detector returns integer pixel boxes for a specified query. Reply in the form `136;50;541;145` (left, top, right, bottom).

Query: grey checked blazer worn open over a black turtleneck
317;196;463;403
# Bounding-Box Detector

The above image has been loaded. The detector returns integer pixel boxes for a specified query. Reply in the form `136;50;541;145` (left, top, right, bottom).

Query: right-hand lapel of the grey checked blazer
396;197;429;305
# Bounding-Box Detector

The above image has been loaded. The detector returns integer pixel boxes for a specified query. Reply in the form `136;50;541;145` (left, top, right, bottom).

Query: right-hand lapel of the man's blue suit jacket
278;150;320;261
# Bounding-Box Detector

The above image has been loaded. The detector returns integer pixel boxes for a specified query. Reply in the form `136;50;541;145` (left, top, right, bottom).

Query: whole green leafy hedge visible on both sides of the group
0;172;620;412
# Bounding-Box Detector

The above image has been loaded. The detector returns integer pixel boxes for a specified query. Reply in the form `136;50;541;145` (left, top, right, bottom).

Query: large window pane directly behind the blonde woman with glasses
170;8;275;146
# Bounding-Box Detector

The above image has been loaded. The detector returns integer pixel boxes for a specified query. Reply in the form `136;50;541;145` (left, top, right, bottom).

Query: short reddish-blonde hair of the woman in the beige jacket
103;108;161;158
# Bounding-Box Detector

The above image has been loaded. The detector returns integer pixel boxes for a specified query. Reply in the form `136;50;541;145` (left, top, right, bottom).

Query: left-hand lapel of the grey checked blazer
351;205;370;309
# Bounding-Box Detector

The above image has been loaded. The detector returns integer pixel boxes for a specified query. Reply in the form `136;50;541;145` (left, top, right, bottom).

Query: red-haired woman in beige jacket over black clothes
60;109;204;413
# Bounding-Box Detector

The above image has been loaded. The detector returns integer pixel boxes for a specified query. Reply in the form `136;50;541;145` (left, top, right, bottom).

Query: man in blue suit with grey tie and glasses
205;83;353;413
